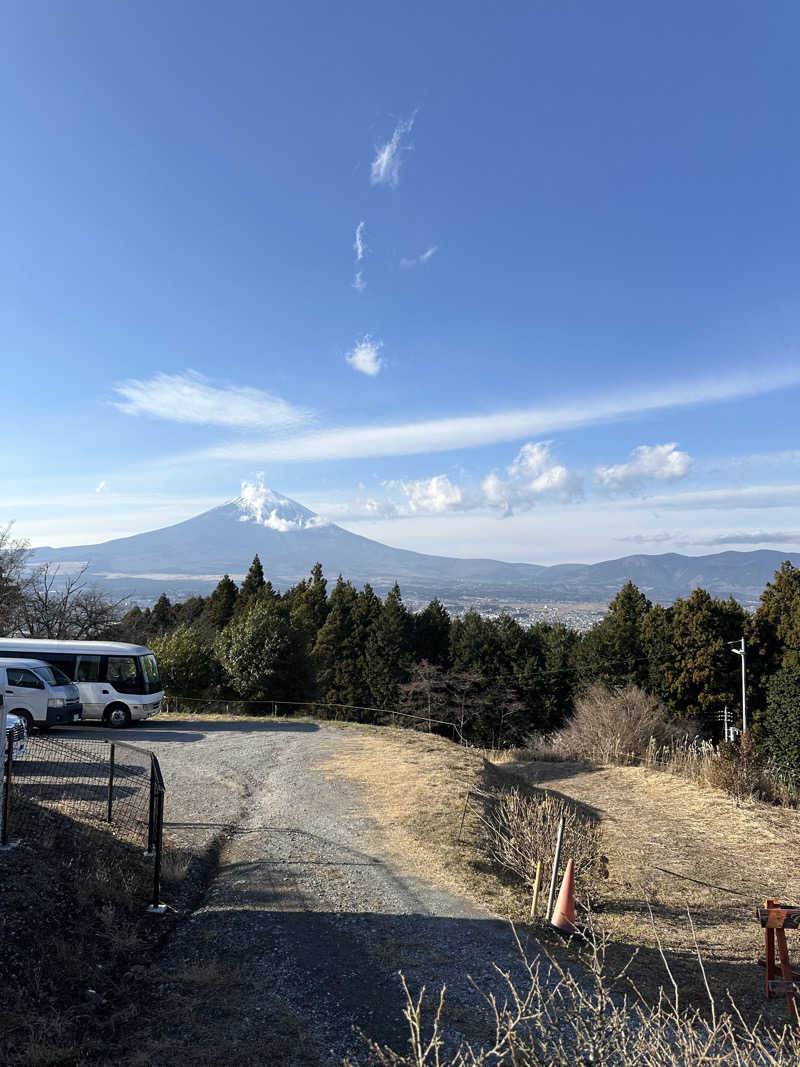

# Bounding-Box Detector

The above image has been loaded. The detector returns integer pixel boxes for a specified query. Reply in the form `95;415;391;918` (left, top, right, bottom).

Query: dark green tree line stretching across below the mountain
0;528;800;768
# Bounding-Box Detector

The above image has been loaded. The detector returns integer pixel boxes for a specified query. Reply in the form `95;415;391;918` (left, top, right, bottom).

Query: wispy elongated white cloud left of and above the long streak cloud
112;370;311;430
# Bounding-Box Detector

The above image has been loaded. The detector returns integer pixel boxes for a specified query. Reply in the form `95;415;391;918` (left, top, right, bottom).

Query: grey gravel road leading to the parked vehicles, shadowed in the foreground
56;720;539;1067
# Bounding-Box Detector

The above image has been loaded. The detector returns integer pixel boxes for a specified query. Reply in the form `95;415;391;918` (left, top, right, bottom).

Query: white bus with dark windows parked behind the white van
0;637;162;727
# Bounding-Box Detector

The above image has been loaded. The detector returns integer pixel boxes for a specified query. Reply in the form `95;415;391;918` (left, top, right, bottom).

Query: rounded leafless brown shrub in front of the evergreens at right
553;685;687;763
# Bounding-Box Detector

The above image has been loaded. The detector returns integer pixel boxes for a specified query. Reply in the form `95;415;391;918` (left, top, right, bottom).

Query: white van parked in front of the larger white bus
0;658;81;733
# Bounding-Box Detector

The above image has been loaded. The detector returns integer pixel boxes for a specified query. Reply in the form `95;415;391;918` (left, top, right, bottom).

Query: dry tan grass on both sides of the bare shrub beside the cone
326;728;800;1024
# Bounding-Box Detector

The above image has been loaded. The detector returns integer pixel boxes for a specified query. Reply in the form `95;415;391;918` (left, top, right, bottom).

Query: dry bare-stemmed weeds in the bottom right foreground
346;935;800;1067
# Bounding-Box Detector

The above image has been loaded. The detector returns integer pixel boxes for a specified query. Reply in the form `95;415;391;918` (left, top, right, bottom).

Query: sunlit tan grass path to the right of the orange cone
501;762;800;1023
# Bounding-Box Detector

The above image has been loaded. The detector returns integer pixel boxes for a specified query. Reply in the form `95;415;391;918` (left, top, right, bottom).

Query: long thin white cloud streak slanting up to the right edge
180;366;800;463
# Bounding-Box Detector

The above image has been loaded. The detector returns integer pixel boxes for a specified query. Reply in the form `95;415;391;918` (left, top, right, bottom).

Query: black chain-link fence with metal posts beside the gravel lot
0;731;166;910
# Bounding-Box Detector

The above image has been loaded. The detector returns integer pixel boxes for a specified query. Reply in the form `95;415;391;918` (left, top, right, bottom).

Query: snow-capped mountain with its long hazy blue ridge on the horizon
33;489;800;603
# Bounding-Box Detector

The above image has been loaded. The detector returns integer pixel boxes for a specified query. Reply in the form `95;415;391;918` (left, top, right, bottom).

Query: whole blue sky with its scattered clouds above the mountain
0;0;800;562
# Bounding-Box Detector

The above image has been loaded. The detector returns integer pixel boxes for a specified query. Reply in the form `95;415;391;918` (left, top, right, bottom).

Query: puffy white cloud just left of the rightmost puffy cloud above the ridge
481;441;583;514
